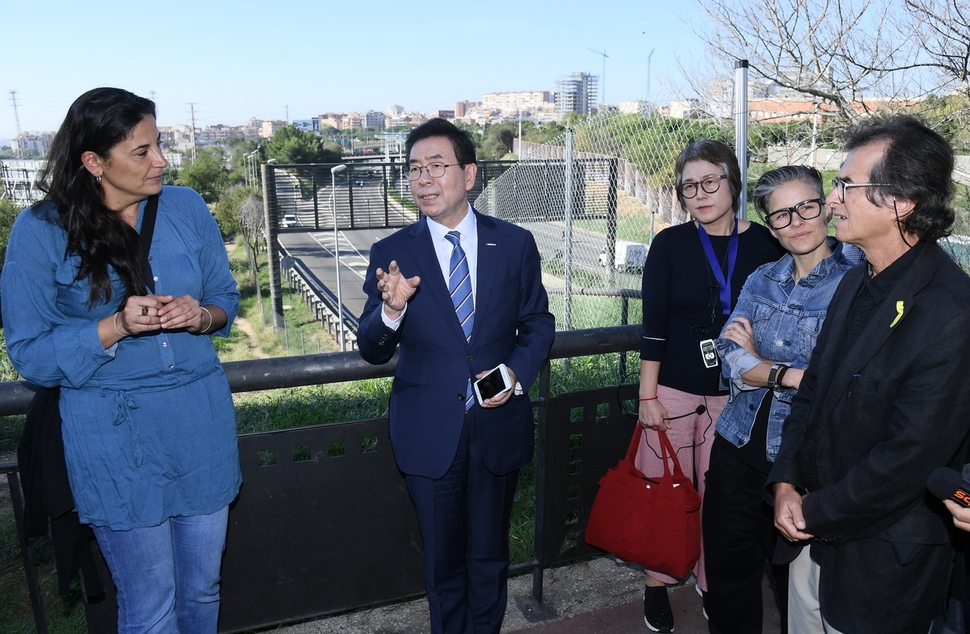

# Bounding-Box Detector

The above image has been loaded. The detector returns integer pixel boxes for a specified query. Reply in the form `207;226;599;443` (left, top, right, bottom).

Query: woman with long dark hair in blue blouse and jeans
2;88;241;632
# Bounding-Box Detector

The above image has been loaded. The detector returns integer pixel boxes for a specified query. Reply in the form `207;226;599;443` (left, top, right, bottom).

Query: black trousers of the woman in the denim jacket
703;436;788;634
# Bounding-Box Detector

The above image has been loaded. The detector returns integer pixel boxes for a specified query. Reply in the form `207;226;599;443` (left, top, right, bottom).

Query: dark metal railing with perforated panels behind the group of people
7;326;640;632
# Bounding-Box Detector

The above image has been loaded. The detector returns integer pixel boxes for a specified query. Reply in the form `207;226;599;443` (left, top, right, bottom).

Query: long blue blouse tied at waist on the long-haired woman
0;187;241;530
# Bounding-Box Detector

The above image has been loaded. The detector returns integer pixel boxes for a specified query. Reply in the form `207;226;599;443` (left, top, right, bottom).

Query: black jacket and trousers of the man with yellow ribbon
768;244;970;632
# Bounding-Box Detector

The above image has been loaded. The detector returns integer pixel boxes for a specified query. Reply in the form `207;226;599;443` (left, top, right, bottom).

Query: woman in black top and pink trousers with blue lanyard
637;140;784;632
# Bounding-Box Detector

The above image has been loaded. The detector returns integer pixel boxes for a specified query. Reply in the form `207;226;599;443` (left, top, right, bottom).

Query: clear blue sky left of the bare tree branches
0;0;704;139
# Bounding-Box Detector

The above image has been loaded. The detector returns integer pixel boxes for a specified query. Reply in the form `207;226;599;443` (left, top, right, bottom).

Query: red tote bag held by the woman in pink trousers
586;424;701;579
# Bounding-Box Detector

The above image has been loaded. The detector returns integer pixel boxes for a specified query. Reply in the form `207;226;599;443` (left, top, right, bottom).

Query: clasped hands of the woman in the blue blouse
115;294;212;335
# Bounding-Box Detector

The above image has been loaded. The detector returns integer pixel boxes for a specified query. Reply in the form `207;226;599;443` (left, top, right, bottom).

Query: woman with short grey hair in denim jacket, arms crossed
702;165;862;634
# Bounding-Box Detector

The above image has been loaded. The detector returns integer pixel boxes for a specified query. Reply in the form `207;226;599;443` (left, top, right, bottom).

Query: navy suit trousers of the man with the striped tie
406;405;519;634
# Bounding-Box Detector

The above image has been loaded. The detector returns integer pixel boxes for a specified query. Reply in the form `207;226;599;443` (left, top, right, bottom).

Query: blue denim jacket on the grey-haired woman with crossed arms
715;237;864;462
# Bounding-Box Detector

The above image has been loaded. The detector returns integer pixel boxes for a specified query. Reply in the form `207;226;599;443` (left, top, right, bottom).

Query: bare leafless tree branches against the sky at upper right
694;0;970;121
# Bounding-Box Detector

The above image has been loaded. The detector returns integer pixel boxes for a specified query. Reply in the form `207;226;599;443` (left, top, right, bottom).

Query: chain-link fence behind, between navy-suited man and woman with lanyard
474;112;734;330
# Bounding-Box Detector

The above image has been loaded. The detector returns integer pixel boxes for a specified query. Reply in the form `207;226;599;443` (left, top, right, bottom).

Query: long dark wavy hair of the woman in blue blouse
37;88;155;307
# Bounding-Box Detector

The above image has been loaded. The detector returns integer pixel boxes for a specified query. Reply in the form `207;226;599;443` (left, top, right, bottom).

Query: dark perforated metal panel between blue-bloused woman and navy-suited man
219;419;424;632
